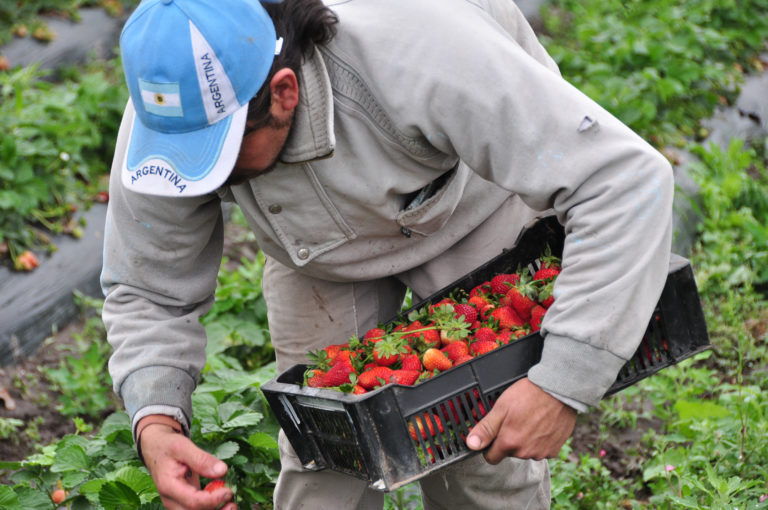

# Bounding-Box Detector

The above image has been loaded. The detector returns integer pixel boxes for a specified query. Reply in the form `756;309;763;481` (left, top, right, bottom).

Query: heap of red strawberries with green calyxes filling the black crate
303;250;560;394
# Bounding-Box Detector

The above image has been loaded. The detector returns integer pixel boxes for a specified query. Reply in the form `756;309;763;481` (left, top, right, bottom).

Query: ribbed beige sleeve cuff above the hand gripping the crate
528;334;626;410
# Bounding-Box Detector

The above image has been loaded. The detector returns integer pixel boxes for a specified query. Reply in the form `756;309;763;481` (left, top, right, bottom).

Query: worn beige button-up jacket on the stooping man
102;0;673;426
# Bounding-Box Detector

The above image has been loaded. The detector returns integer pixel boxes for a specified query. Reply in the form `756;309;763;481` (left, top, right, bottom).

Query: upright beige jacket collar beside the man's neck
280;49;336;164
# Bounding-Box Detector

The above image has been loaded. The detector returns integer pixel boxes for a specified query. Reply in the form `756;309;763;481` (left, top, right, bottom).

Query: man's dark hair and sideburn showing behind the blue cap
247;0;339;131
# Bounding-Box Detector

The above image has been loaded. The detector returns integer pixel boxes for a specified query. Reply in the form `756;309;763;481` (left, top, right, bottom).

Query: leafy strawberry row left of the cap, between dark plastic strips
0;61;127;259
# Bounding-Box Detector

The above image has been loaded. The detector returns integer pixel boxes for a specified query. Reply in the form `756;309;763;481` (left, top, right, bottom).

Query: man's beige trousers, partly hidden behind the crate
263;198;550;510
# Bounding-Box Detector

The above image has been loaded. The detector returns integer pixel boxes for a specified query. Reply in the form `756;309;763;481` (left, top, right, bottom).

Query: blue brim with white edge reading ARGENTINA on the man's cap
122;98;248;197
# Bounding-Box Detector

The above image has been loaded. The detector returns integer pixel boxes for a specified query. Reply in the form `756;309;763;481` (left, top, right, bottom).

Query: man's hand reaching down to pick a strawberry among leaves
140;423;237;510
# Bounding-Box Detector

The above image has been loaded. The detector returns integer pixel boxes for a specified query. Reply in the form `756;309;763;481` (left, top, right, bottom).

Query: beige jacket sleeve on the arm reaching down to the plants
101;100;223;422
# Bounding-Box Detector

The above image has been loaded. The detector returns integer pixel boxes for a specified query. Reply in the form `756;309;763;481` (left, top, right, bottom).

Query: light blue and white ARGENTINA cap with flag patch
120;0;282;196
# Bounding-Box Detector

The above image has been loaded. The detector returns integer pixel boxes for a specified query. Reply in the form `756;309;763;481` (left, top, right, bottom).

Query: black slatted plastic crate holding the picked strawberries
261;217;710;491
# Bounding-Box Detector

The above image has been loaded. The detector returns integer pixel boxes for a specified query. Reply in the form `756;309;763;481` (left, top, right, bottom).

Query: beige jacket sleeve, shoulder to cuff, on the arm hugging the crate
348;0;674;405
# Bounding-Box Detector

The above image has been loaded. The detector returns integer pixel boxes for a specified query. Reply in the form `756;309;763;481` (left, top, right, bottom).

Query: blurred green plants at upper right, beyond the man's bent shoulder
542;0;768;146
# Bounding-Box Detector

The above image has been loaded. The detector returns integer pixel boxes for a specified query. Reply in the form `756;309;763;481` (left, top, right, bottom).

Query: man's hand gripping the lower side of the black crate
467;378;576;464
